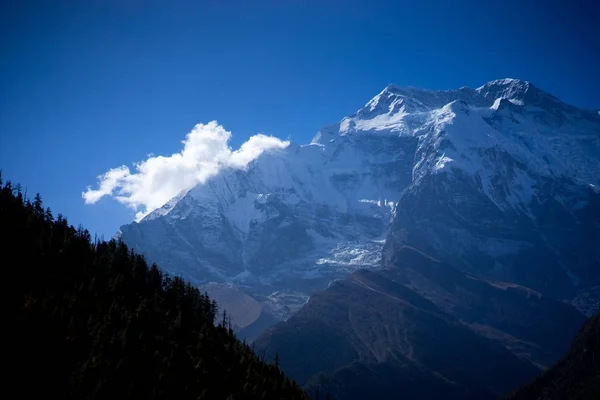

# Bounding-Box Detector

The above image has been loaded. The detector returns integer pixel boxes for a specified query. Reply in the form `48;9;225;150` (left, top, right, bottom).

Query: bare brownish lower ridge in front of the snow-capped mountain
255;246;585;399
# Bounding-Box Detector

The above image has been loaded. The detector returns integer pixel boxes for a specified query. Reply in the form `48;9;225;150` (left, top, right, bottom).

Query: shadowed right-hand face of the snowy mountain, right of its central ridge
386;80;600;297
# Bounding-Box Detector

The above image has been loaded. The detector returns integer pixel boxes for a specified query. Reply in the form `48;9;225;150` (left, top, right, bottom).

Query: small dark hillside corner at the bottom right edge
509;311;600;400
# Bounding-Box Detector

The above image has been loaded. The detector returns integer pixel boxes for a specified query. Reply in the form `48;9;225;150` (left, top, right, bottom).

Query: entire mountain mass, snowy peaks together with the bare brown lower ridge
119;79;600;399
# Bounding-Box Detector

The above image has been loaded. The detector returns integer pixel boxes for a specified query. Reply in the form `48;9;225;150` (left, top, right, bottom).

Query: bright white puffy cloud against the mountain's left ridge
81;121;289;221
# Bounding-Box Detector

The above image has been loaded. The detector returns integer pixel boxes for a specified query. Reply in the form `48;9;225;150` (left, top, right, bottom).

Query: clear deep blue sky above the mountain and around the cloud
0;0;600;236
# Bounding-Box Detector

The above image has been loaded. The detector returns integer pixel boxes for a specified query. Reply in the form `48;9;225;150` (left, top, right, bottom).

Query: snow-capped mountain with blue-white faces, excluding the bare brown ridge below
120;79;600;314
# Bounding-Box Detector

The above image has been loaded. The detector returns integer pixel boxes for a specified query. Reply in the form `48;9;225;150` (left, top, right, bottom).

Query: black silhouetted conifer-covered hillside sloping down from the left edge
0;174;307;399
